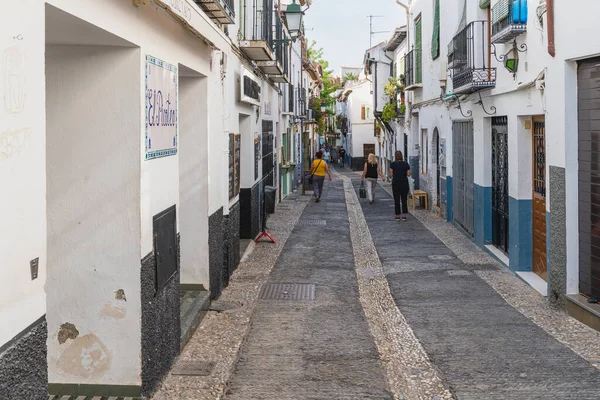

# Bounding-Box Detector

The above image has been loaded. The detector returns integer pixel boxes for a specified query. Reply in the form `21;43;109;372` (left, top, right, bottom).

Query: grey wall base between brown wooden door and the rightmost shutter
546;165;567;308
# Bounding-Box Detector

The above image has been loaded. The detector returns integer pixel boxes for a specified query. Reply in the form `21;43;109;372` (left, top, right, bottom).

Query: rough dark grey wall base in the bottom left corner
0;316;48;400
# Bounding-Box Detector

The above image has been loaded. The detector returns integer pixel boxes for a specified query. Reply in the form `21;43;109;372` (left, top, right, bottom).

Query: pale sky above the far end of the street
304;0;406;74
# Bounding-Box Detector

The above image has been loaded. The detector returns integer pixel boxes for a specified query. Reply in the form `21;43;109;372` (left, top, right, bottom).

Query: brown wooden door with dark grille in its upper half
533;117;547;280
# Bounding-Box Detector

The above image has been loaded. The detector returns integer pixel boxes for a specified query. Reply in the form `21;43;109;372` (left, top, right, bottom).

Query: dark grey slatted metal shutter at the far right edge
577;58;600;298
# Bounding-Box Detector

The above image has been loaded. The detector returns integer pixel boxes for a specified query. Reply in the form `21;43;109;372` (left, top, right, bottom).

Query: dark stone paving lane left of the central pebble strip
227;180;393;400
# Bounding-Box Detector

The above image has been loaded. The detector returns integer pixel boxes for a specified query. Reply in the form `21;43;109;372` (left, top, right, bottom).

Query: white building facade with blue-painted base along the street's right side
405;0;600;327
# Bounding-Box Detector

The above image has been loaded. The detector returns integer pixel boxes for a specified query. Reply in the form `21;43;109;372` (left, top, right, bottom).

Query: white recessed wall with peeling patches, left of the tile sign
46;46;142;384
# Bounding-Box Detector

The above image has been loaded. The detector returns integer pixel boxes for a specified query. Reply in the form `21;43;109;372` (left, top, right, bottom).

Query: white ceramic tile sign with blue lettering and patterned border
146;55;178;160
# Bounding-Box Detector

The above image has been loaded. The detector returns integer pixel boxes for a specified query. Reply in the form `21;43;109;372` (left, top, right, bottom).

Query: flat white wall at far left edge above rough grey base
0;0;46;346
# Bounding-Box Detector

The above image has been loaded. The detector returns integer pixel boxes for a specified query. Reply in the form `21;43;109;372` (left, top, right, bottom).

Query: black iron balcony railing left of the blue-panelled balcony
448;21;496;94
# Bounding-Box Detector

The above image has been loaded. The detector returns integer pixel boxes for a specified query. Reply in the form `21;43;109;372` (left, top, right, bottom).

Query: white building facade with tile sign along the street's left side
0;0;314;399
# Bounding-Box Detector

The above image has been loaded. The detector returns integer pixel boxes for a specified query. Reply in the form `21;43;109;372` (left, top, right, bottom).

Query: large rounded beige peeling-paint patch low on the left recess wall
58;334;111;378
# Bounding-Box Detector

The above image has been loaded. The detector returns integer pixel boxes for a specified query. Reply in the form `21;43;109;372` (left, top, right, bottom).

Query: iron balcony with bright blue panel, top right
492;0;527;43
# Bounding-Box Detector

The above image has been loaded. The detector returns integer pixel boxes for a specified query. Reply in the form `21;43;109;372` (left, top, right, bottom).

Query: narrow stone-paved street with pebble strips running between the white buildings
155;166;600;400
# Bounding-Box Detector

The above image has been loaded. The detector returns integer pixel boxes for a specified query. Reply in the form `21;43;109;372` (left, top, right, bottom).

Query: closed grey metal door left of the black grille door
452;121;475;236
